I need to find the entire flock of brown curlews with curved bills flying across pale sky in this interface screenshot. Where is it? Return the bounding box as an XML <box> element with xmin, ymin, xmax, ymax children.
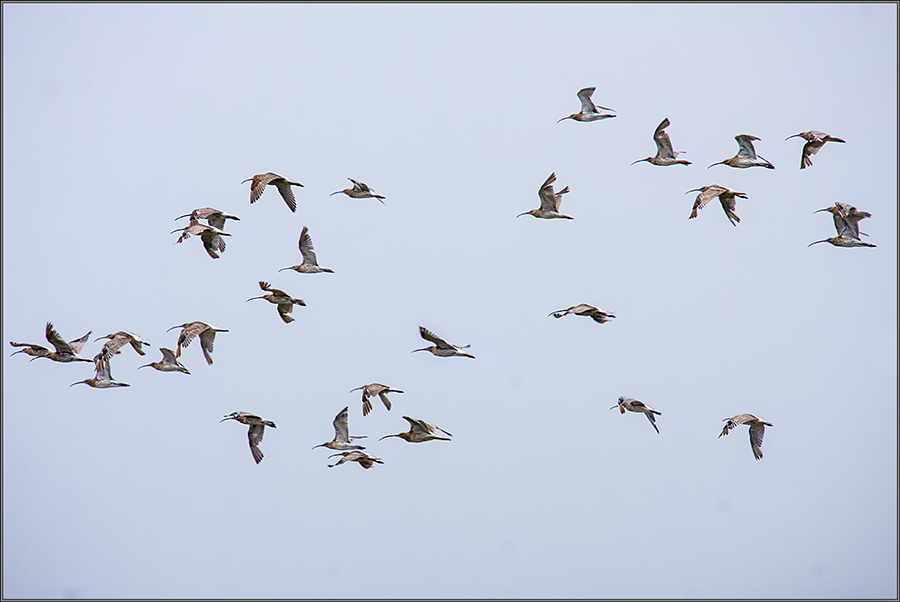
<box><xmin>10</xmin><ymin>87</ymin><xmax>875</xmax><ymax>468</ymax></box>
